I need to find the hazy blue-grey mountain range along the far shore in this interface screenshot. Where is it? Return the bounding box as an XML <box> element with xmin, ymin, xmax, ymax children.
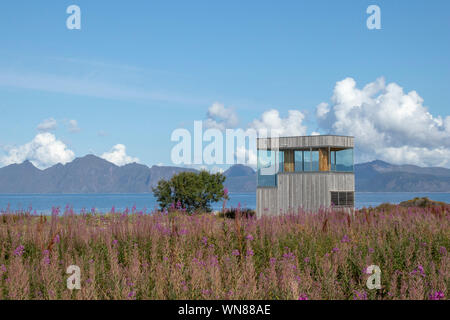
<box><xmin>0</xmin><ymin>155</ymin><xmax>450</xmax><ymax>193</ymax></box>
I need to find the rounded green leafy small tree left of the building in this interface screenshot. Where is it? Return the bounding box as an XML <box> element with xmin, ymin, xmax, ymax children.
<box><xmin>153</xmin><ymin>170</ymin><xmax>228</xmax><ymax>213</ymax></box>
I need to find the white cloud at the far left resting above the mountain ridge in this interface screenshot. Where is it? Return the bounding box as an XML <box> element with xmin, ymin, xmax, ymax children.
<box><xmin>0</xmin><ymin>132</ymin><xmax>75</xmax><ymax>169</ymax></box>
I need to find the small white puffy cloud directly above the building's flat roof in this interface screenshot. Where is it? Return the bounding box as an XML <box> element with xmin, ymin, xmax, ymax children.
<box><xmin>249</xmin><ymin>109</ymin><xmax>307</xmax><ymax>136</ymax></box>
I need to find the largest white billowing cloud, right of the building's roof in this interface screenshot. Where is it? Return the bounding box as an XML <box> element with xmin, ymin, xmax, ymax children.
<box><xmin>316</xmin><ymin>78</ymin><xmax>450</xmax><ymax>167</ymax></box>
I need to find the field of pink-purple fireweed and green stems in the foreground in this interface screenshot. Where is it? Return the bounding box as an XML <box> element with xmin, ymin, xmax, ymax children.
<box><xmin>0</xmin><ymin>207</ymin><xmax>450</xmax><ymax>300</ymax></box>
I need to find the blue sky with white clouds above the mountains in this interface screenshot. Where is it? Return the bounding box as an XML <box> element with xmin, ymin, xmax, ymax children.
<box><xmin>0</xmin><ymin>0</ymin><xmax>450</xmax><ymax>170</ymax></box>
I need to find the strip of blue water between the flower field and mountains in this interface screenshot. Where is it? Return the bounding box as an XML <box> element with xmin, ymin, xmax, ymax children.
<box><xmin>0</xmin><ymin>192</ymin><xmax>450</xmax><ymax>213</ymax></box>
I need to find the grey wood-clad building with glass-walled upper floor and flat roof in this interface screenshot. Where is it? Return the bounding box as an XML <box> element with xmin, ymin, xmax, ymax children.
<box><xmin>256</xmin><ymin>135</ymin><xmax>355</xmax><ymax>216</ymax></box>
